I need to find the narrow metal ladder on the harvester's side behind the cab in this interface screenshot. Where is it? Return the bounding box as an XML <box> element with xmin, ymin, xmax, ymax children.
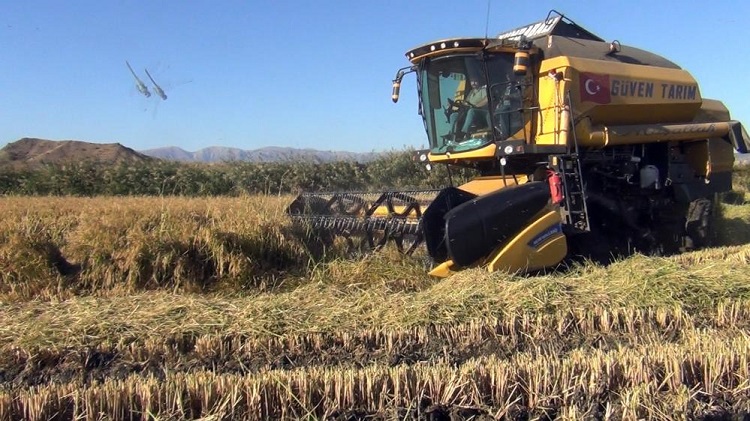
<box><xmin>557</xmin><ymin>92</ymin><xmax>591</xmax><ymax>231</ymax></box>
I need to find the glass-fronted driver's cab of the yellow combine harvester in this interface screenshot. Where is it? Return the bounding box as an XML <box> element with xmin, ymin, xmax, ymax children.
<box><xmin>394</xmin><ymin>39</ymin><xmax>532</xmax><ymax>155</ymax></box>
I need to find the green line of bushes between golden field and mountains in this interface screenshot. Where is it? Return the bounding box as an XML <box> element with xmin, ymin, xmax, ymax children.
<box><xmin>0</xmin><ymin>151</ymin><xmax>466</xmax><ymax>196</ymax></box>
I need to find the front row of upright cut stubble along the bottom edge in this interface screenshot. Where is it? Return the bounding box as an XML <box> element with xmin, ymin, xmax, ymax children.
<box><xmin>0</xmin><ymin>331</ymin><xmax>750</xmax><ymax>420</ymax></box>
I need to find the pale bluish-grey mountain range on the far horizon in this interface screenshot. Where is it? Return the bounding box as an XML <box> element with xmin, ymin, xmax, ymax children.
<box><xmin>141</xmin><ymin>146</ymin><xmax>379</xmax><ymax>163</ymax></box>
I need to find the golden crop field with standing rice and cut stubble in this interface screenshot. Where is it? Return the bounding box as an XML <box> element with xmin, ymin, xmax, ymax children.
<box><xmin>0</xmin><ymin>185</ymin><xmax>750</xmax><ymax>420</ymax></box>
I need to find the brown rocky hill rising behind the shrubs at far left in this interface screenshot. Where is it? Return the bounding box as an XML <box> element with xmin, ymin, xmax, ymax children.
<box><xmin>0</xmin><ymin>137</ymin><xmax>153</xmax><ymax>169</ymax></box>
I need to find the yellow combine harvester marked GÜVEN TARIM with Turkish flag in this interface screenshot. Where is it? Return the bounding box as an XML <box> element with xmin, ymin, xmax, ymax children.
<box><xmin>288</xmin><ymin>11</ymin><xmax>750</xmax><ymax>277</ymax></box>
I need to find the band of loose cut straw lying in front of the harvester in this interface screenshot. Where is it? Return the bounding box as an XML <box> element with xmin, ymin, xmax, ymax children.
<box><xmin>0</xmin><ymin>241</ymin><xmax>750</xmax><ymax>347</ymax></box>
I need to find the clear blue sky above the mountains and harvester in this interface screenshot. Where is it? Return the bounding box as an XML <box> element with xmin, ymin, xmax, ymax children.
<box><xmin>0</xmin><ymin>0</ymin><xmax>750</xmax><ymax>151</ymax></box>
